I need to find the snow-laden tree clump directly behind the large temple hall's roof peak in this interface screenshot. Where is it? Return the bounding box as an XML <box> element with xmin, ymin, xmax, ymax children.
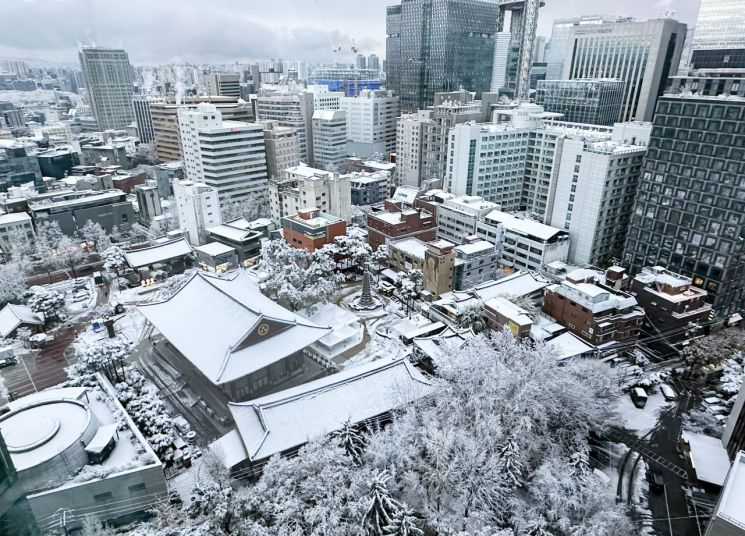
<box><xmin>261</xmin><ymin>239</ymin><xmax>338</xmax><ymax>311</ymax></box>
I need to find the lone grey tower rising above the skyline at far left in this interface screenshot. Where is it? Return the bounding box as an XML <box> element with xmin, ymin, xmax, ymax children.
<box><xmin>79</xmin><ymin>47</ymin><xmax>134</xmax><ymax>130</ymax></box>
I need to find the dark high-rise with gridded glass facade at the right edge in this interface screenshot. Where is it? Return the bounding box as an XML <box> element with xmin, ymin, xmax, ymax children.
<box><xmin>624</xmin><ymin>83</ymin><xmax>745</xmax><ymax>317</ymax></box>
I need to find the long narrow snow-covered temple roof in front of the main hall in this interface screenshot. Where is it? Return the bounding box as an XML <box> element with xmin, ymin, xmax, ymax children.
<box><xmin>228</xmin><ymin>357</ymin><xmax>434</xmax><ymax>461</ymax></box>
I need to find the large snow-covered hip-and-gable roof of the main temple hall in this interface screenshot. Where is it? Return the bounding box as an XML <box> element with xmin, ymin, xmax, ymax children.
<box><xmin>139</xmin><ymin>273</ymin><xmax>331</xmax><ymax>385</ymax></box>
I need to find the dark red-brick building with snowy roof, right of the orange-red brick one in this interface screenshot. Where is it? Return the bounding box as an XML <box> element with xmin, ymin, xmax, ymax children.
<box><xmin>367</xmin><ymin>200</ymin><xmax>437</xmax><ymax>249</ymax></box>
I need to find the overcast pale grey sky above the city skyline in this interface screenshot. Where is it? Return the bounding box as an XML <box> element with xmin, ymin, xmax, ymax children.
<box><xmin>0</xmin><ymin>0</ymin><xmax>700</xmax><ymax>65</ymax></box>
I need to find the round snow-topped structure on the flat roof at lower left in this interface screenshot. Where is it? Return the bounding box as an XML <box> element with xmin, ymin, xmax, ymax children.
<box><xmin>0</xmin><ymin>398</ymin><xmax>98</xmax><ymax>489</ymax></box>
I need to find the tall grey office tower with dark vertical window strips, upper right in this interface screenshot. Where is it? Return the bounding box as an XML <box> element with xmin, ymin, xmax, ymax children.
<box><xmin>552</xmin><ymin>19</ymin><xmax>686</xmax><ymax>121</ymax></box>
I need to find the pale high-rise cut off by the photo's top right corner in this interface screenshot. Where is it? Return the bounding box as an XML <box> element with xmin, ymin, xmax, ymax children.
<box><xmin>690</xmin><ymin>0</ymin><xmax>745</xmax><ymax>69</ymax></box>
